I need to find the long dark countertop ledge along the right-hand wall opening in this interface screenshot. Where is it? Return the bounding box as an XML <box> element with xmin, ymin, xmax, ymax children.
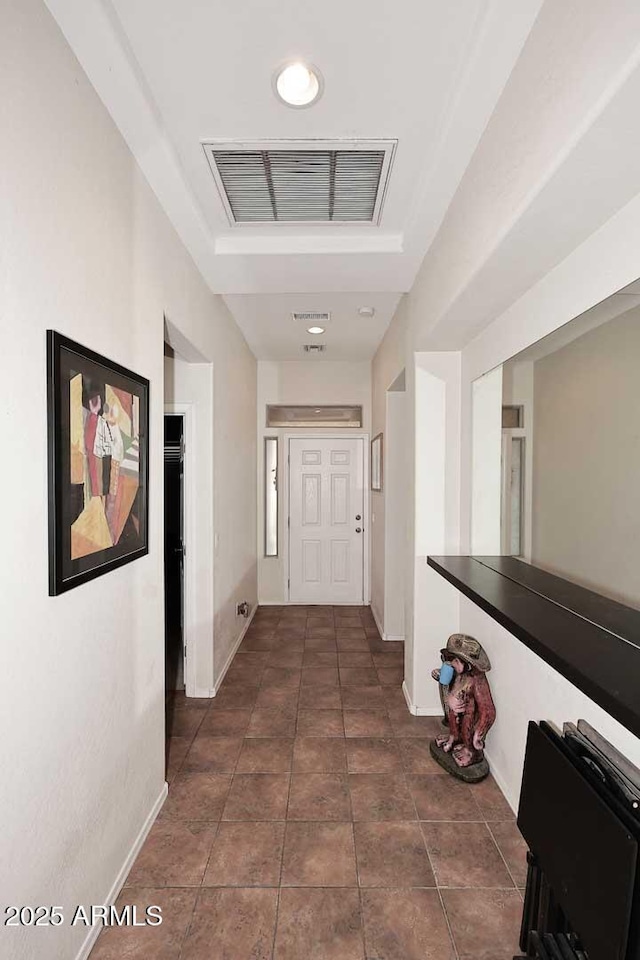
<box><xmin>427</xmin><ymin>556</ymin><xmax>640</xmax><ymax>737</ymax></box>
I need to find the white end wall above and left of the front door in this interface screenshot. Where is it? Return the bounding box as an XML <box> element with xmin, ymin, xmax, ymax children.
<box><xmin>257</xmin><ymin>360</ymin><xmax>371</xmax><ymax>603</ymax></box>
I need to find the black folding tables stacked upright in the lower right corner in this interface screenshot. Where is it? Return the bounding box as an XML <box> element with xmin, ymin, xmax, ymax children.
<box><xmin>514</xmin><ymin>722</ymin><xmax>640</xmax><ymax>960</ymax></box>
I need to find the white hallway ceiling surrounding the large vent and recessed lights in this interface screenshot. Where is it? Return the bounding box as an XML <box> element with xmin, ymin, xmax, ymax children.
<box><xmin>47</xmin><ymin>0</ymin><xmax>542</xmax><ymax>359</ymax></box>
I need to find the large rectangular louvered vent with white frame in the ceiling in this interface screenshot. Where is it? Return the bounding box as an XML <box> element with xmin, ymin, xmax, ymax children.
<box><xmin>202</xmin><ymin>140</ymin><xmax>396</xmax><ymax>224</ymax></box>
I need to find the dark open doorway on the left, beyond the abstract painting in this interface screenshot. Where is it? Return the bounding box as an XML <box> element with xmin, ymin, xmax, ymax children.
<box><xmin>164</xmin><ymin>414</ymin><xmax>185</xmax><ymax>704</ymax></box>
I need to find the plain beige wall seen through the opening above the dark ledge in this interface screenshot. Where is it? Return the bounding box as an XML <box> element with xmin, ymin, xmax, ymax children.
<box><xmin>533</xmin><ymin>308</ymin><xmax>640</xmax><ymax>607</ymax></box>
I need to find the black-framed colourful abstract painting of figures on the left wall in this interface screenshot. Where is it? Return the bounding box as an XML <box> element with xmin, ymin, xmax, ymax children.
<box><xmin>47</xmin><ymin>330</ymin><xmax>149</xmax><ymax>596</ymax></box>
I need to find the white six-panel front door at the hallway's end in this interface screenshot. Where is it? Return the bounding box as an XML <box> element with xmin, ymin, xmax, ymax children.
<box><xmin>289</xmin><ymin>437</ymin><xmax>364</xmax><ymax>603</ymax></box>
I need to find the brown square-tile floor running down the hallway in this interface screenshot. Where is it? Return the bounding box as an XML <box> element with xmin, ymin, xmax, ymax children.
<box><xmin>91</xmin><ymin>607</ymin><xmax>525</xmax><ymax>960</ymax></box>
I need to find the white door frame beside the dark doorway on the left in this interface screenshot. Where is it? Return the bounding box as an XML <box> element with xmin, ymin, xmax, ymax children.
<box><xmin>163</xmin><ymin>401</ymin><xmax>198</xmax><ymax>697</ymax></box>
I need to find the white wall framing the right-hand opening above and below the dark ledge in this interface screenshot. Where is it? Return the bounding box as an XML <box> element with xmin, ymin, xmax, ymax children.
<box><xmin>459</xmin><ymin>198</ymin><xmax>640</xmax><ymax>805</ymax></box>
